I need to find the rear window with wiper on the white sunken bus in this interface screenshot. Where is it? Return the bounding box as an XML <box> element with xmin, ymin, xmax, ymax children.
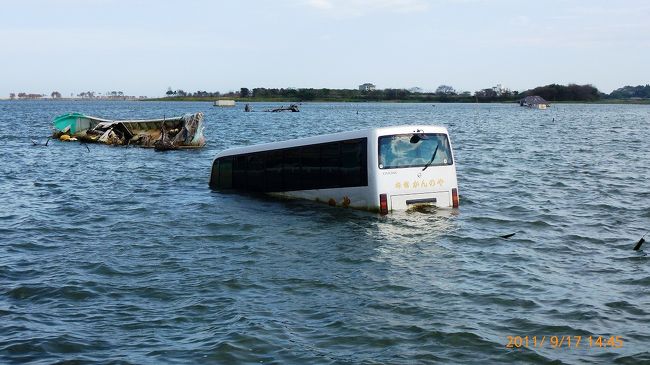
<box><xmin>379</xmin><ymin>133</ymin><xmax>453</xmax><ymax>169</ymax></box>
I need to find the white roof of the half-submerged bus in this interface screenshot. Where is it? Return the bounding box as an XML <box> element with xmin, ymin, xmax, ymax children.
<box><xmin>215</xmin><ymin>125</ymin><xmax>448</xmax><ymax>159</ymax></box>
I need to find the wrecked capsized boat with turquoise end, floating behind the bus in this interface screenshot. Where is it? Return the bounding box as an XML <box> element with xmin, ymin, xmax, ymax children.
<box><xmin>53</xmin><ymin>112</ymin><xmax>205</xmax><ymax>150</ymax></box>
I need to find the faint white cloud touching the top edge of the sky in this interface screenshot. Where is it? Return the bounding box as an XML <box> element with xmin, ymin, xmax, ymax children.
<box><xmin>305</xmin><ymin>0</ymin><xmax>429</xmax><ymax>17</ymax></box>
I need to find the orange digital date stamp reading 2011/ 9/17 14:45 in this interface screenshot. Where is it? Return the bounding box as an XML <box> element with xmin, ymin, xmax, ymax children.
<box><xmin>506</xmin><ymin>336</ymin><xmax>623</xmax><ymax>349</ymax></box>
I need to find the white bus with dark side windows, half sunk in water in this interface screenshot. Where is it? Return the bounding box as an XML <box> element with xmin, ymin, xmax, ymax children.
<box><xmin>210</xmin><ymin>125</ymin><xmax>459</xmax><ymax>214</ymax></box>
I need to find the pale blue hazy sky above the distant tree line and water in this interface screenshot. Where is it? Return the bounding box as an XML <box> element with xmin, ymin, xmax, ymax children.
<box><xmin>0</xmin><ymin>0</ymin><xmax>650</xmax><ymax>98</ymax></box>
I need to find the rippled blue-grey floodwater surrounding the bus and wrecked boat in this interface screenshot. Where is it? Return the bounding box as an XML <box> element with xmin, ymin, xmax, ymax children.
<box><xmin>0</xmin><ymin>101</ymin><xmax>650</xmax><ymax>364</ymax></box>
